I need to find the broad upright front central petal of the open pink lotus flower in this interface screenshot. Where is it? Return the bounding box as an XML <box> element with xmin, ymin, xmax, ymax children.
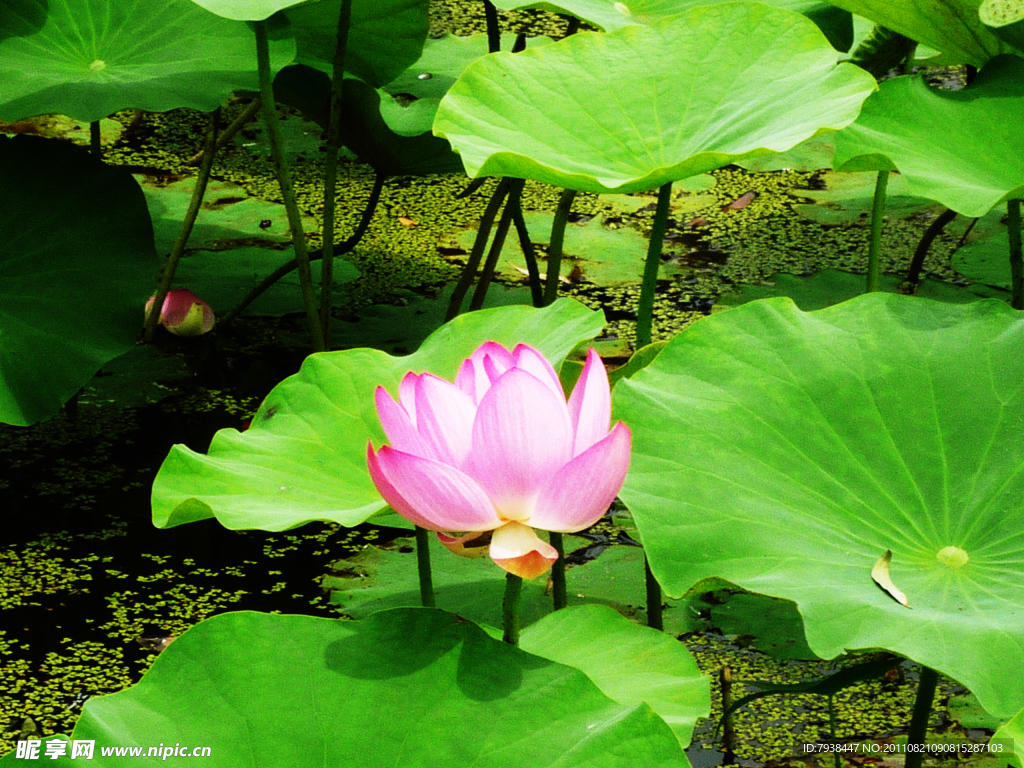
<box><xmin>462</xmin><ymin>369</ymin><xmax>572</xmax><ymax>530</ymax></box>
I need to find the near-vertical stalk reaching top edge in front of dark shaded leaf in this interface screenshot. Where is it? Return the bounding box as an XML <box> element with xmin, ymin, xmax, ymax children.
<box><xmin>321</xmin><ymin>0</ymin><xmax>352</xmax><ymax>349</ymax></box>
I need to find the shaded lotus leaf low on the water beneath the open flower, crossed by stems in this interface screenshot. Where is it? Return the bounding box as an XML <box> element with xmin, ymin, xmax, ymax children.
<box><xmin>323</xmin><ymin>536</ymin><xmax>703</xmax><ymax>635</ymax></box>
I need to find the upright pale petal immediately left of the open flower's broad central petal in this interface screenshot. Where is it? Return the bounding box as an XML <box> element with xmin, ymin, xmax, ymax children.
<box><xmin>415</xmin><ymin>374</ymin><xmax>476</xmax><ymax>467</ymax></box>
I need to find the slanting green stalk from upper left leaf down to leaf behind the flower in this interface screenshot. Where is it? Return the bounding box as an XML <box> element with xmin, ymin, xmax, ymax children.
<box><xmin>254</xmin><ymin>19</ymin><xmax>326</xmax><ymax>352</ymax></box>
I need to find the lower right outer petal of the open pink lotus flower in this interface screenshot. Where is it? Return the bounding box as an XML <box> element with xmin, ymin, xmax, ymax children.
<box><xmin>529</xmin><ymin>422</ymin><xmax>633</xmax><ymax>534</ymax></box>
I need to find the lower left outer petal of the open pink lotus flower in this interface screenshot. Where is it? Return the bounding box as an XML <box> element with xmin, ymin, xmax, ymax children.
<box><xmin>367</xmin><ymin>444</ymin><xmax>504</xmax><ymax>530</ymax></box>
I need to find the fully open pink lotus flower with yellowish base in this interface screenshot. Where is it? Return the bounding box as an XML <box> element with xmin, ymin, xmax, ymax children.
<box><xmin>367</xmin><ymin>341</ymin><xmax>632</xmax><ymax>579</ymax></box>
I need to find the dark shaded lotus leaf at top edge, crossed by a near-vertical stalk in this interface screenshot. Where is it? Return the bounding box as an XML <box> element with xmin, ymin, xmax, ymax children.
<box><xmin>287</xmin><ymin>0</ymin><xmax>430</xmax><ymax>86</ymax></box>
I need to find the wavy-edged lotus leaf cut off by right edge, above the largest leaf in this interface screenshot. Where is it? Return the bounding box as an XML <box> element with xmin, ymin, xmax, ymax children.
<box><xmin>835</xmin><ymin>56</ymin><xmax>1024</xmax><ymax>216</ymax></box>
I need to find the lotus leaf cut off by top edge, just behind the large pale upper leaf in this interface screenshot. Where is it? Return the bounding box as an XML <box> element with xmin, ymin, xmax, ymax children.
<box><xmin>495</xmin><ymin>0</ymin><xmax>853</xmax><ymax>50</ymax></box>
